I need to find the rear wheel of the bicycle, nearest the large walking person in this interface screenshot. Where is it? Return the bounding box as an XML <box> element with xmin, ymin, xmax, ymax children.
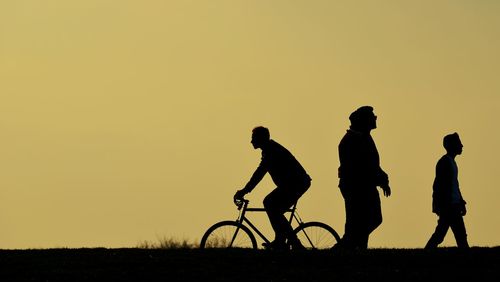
<box><xmin>294</xmin><ymin>221</ymin><xmax>340</xmax><ymax>250</ymax></box>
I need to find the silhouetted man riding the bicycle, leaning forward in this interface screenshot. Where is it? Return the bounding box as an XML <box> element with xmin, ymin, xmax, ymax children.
<box><xmin>234</xmin><ymin>126</ymin><xmax>311</xmax><ymax>250</ymax></box>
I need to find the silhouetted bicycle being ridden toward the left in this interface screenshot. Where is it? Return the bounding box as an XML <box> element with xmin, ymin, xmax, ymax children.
<box><xmin>200</xmin><ymin>199</ymin><xmax>340</xmax><ymax>250</ymax></box>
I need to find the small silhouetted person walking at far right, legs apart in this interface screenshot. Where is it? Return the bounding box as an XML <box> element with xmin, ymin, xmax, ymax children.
<box><xmin>425</xmin><ymin>132</ymin><xmax>469</xmax><ymax>249</ymax></box>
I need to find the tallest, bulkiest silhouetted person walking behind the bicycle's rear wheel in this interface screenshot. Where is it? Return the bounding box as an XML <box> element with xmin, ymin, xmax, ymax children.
<box><xmin>334</xmin><ymin>106</ymin><xmax>391</xmax><ymax>250</ymax></box>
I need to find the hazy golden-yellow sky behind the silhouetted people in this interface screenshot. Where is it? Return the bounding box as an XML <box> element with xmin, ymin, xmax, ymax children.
<box><xmin>0</xmin><ymin>0</ymin><xmax>500</xmax><ymax>249</ymax></box>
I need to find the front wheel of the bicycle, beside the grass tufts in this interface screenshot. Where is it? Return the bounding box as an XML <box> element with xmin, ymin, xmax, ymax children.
<box><xmin>200</xmin><ymin>221</ymin><xmax>257</xmax><ymax>249</ymax></box>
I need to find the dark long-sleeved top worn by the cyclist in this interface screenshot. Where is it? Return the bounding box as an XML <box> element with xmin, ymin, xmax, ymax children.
<box><xmin>244</xmin><ymin>140</ymin><xmax>311</xmax><ymax>192</ymax></box>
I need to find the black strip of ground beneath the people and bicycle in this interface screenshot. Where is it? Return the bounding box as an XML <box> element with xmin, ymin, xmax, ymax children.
<box><xmin>0</xmin><ymin>247</ymin><xmax>500</xmax><ymax>282</ymax></box>
